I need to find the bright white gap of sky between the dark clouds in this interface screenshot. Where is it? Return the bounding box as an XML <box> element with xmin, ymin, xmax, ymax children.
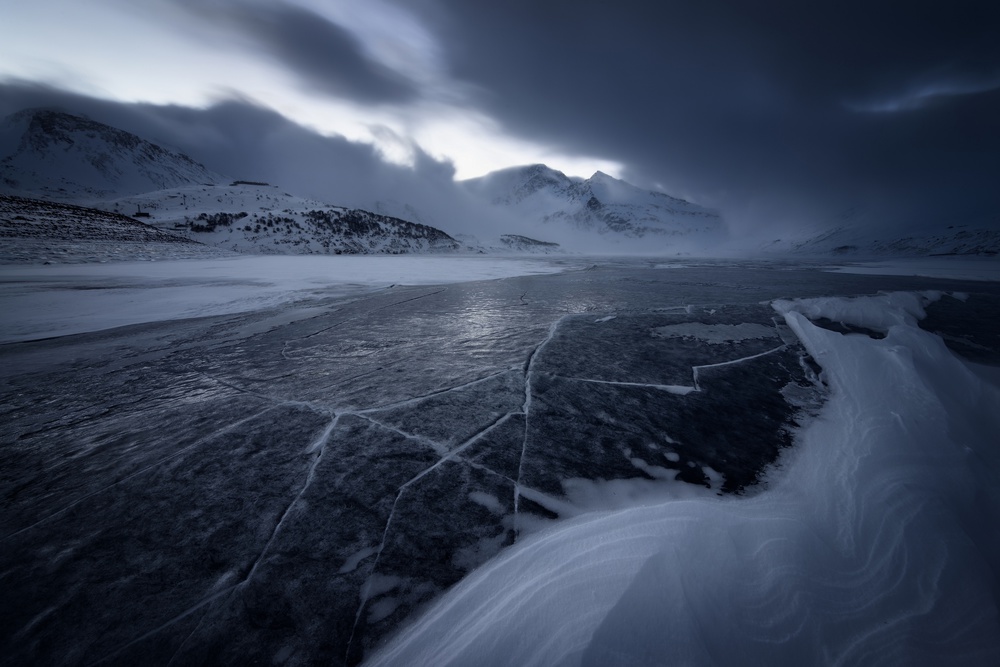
<box><xmin>0</xmin><ymin>0</ymin><xmax>622</xmax><ymax>179</ymax></box>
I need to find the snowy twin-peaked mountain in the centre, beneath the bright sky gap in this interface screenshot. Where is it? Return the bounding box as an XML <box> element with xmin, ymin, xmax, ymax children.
<box><xmin>462</xmin><ymin>164</ymin><xmax>725</xmax><ymax>249</ymax></box>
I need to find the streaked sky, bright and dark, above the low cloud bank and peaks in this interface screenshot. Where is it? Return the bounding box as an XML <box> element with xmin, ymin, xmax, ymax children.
<box><xmin>0</xmin><ymin>0</ymin><xmax>1000</xmax><ymax>237</ymax></box>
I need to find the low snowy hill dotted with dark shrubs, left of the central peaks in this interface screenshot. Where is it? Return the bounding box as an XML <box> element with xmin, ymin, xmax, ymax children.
<box><xmin>92</xmin><ymin>181</ymin><xmax>459</xmax><ymax>255</ymax></box>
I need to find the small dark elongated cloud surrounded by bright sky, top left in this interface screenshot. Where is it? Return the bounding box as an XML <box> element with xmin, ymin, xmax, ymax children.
<box><xmin>176</xmin><ymin>0</ymin><xmax>418</xmax><ymax>104</ymax></box>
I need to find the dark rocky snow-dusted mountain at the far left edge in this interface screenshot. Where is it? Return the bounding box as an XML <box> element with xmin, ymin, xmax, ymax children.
<box><xmin>0</xmin><ymin>109</ymin><xmax>227</xmax><ymax>201</ymax></box>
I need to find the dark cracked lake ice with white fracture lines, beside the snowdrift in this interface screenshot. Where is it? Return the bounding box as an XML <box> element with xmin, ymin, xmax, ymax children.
<box><xmin>0</xmin><ymin>269</ymin><xmax>1000</xmax><ymax>665</ymax></box>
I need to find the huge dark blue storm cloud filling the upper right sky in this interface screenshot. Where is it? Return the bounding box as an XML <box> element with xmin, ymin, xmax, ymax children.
<box><xmin>401</xmin><ymin>0</ymin><xmax>1000</xmax><ymax>235</ymax></box>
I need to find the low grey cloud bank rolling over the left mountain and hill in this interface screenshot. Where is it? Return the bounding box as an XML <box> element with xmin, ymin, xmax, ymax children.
<box><xmin>0</xmin><ymin>82</ymin><xmax>526</xmax><ymax>236</ymax></box>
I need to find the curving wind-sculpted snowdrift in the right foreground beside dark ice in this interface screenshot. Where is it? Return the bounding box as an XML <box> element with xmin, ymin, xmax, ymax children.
<box><xmin>369</xmin><ymin>294</ymin><xmax>1000</xmax><ymax>665</ymax></box>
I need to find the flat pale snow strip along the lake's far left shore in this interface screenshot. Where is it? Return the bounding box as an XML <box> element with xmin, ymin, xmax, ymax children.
<box><xmin>0</xmin><ymin>255</ymin><xmax>568</xmax><ymax>343</ymax></box>
